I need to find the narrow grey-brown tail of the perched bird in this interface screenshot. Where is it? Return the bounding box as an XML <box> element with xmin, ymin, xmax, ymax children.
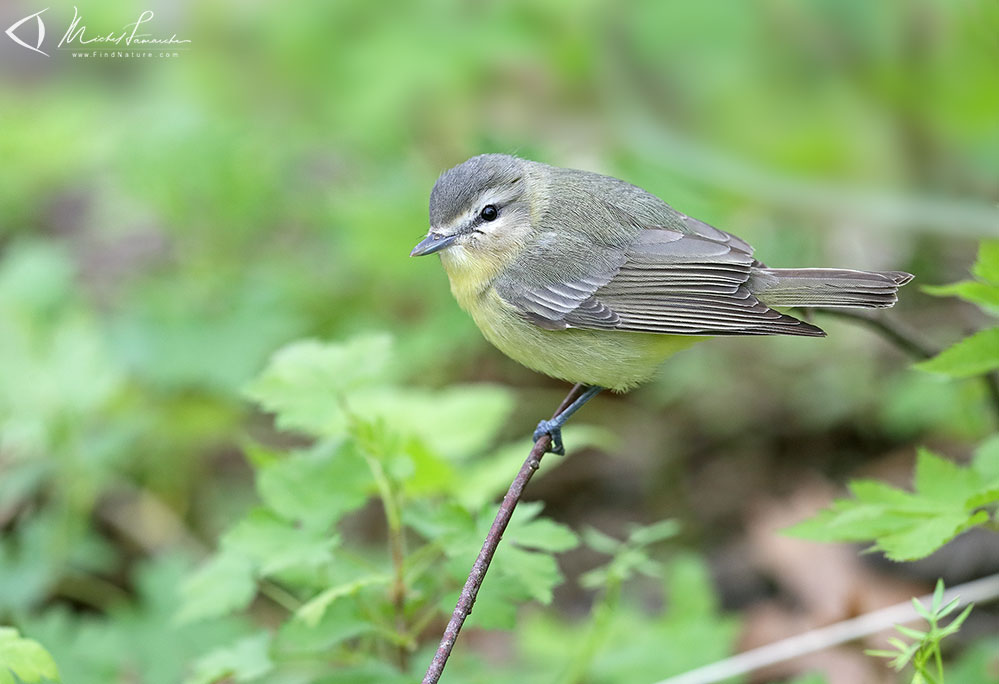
<box><xmin>749</xmin><ymin>267</ymin><xmax>912</xmax><ymax>309</ymax></box>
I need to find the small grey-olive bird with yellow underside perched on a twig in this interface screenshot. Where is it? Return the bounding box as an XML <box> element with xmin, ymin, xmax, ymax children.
<box><xmin>410</xmin><ymin>154</ymin><xmax>912</xmax><ymax>453</ymax></box>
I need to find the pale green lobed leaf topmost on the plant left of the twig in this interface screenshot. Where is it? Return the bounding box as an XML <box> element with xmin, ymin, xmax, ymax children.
<box><xmin>246</xmin><ymin>335</ymin><xmax>391</xmax><ymax>437</ymax></box>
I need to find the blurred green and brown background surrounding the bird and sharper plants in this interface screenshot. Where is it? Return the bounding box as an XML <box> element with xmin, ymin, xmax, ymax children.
<box><xmin>0</xmin><ymin>0</ymin><xmax>999</xmax><ymax>682</ymax></box>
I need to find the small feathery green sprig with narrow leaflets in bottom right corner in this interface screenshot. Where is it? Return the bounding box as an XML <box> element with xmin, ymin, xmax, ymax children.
<box><xmin>867</xmin><ymin>580</ymin><xmax>974</xmax><ymax>684</ymax></box>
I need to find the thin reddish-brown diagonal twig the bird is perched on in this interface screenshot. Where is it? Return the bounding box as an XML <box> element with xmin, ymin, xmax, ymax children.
<box><xmin>423</xmin><ymin>385</ymin><xmax>584</xmax><ymax>684</ymax></box>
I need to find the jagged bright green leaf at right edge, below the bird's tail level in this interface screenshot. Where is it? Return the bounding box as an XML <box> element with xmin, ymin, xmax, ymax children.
<box><xmin>788</xmin><ymin>444</ymin><xmax>999</xmax><ymax>561</ymax></box>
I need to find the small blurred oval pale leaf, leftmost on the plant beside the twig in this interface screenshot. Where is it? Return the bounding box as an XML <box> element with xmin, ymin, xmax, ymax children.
<box><xmin>176</xmin><ymin>552</ymin><xmax>257</xmax><ymax>624</ymax></box>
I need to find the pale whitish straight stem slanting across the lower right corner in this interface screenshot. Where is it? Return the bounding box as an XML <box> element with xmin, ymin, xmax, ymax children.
<box><xmin>657</xmin><ymin>574</ymin><xmax>999</xmax><ymax>684</ymax></box>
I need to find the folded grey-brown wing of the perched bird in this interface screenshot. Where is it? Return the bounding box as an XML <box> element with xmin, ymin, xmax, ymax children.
<box><xmin>497</xmin><ymin>208</ymin><xmax>824</xmax><ymax>336</ymax></box>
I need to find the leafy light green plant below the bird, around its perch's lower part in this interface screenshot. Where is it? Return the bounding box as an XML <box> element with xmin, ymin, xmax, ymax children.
<box><xmin>177</xmin><ymin>335</ymin><xmax>585</xmax><ymax>682</ymax></box>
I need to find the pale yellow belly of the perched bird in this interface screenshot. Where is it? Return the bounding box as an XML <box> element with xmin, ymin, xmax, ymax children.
<box><xmin>455</xmin><ymin>288</ymin><xmax>707</xmax><ymax>392</ymax></box>
